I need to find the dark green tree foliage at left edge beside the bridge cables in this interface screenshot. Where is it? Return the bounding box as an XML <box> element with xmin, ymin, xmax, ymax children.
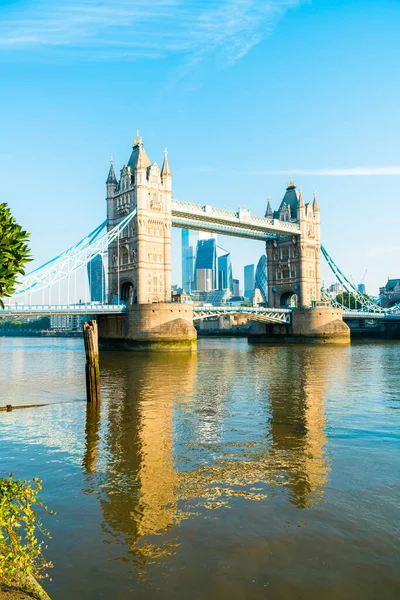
<box><xmin>0</xmin><ymin>202</ymin><xmax>31</xmax><ymax>308</ymax></box>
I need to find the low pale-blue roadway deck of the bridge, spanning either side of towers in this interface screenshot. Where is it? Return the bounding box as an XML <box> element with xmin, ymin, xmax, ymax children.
<box><xmin>0</xmin><ymin>302</ymin><xmax>400</xmax><ymax>324</ymax></box>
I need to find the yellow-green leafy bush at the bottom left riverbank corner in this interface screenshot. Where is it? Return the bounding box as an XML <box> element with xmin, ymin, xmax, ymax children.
<box><xmin>0</xmin><ymin>474</ymin><xmax>54</xmax><ymax>589</ymax></box>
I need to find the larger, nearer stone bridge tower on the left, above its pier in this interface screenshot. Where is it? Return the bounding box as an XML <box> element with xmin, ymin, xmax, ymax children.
<box><xmin>106</xmin><ymin>134</ymin><xmax>172</xmax><ymax>304</ymax></box>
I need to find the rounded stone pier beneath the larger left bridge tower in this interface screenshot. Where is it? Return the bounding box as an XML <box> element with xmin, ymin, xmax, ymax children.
<box><xmin>99</xmin><ymin>304</ymin><xmax>197</xmax><ymax>352</ymax></box>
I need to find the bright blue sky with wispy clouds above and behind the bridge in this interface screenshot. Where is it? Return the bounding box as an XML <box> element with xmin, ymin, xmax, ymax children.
<box><xmin>0</xmin><ymin>0</ymin><xmax>400</xmax><ymax>293</ymax></box>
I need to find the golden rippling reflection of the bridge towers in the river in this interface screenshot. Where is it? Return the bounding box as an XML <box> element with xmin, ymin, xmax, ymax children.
<box><xmin>83</xmin><ymin>341</ymin><xmax>345</xmax><ymax>561</ymax></box>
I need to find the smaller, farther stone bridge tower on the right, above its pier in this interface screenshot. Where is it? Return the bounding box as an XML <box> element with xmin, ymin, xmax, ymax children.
<box><xmin>265</xmin><ymin>180</ymin><xmax>321</xmax><ymax>308</ymax></box>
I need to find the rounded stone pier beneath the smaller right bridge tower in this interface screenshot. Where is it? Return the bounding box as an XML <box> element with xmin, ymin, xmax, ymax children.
<box><xmin>248</xmin><ymin>307</ymin><xmax>350</xmax><ymax>344</ymax></box>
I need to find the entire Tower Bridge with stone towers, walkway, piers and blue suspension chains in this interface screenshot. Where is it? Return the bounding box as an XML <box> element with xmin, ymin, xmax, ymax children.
<box><xmin>0</xmin><ymin>135</ymin><xmax>396</xmax><ymax>349</ymax></box>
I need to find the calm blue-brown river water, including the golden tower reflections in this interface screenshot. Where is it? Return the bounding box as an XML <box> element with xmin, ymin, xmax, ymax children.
<box><xmin>0</xmin><ymin>338</ymin><xmax>400</xmax><ymax>600</ymax></box>
